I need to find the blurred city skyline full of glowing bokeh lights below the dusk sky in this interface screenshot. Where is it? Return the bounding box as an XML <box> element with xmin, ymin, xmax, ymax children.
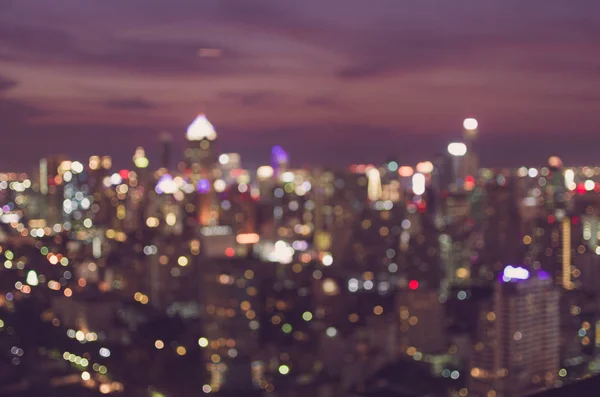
<box><xmin>0</xmin><ymin>114</ymin><xmax>600</xmax><ymax>397</ymax></box>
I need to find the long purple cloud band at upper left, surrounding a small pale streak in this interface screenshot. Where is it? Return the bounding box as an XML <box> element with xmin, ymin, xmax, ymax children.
<box><xmin>0</xmin><ymin>24</ymin><xmax>274</xmax><ymax>76</ymax></box>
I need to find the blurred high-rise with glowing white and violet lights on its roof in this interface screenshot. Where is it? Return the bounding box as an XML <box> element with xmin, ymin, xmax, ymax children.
<box><xmin>468</xmin><ymin>266</ymin><xmax>560</xmax><ymax>397</ymax></box>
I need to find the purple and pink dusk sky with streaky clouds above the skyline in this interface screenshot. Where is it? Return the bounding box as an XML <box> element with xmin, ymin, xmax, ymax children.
<box><xmin>0</xmin><ymin>0</ymin><xmax>600</xmax><ymax>170</ymax></box>
